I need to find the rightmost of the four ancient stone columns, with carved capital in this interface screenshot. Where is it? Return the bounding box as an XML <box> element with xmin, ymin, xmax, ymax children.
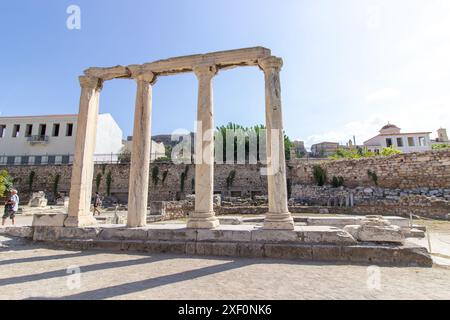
<box><xmin>259</xmin><ymin>57</ymin><xmax>294</xmax><ymax>230</ymax></box>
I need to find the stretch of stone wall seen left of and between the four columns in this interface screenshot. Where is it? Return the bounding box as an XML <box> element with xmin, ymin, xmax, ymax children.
<box><xmin>4</xmin><ymin>162</ymin><xmax>267</xmax><ymax>202</ymax></box>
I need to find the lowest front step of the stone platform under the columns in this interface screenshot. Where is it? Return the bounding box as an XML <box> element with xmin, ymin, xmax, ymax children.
<box><xmin>44</xmin><ymin>239</ymin><xmax>433</xmax><ymax>267</ymax></box>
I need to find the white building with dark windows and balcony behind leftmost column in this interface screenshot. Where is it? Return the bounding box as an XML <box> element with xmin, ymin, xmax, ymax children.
<box><xmin>0</xmin><ymin>113</ymin><xmax>123</xmax><ymax>165</ymax></box>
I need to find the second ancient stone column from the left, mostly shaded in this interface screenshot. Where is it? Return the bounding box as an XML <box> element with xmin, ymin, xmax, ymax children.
<box><xmin>127</xmin><ymin>73</ymin><xmax>155</xmax><ymax>228</ymax></box>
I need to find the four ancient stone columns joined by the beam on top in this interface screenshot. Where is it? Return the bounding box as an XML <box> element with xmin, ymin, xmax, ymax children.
<box><xmin>65</xmin><ymin>47</ymin><xmax>294</xmax><ymax>230</ymax></box>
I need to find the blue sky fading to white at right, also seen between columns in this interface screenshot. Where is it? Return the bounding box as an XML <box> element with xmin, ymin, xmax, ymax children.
<box><xmin>0</xmin><ymin>0</ymin><xmax>450</xmax><ymax>145</ymax></box>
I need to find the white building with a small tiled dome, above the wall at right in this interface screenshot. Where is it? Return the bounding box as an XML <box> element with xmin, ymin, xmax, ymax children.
<box><xmin>364</xmin><ymin>123</ymin><xmax>431</xmax><ymax>153</ymax></box>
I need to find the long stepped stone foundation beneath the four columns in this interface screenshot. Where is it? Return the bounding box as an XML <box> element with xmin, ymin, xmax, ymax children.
<box><xmin>0</xmin><ymin>225</ymin><xmax>432</xmax><ymax>267</ymax></box>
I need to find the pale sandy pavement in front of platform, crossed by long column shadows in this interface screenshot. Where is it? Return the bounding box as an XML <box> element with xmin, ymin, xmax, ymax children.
<box><xmin>0</xmin><ymin>237</ymin><xmax>450</xmax><ymax>299</ymax></box>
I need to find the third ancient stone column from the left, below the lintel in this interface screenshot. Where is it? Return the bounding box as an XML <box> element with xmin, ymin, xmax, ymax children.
<box><xmin>187</xmin><ymin>65</ymin><xmax>219</xmax><ymax>229</ymax></box>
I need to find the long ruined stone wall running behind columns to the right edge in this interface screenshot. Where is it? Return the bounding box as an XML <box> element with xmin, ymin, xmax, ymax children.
<box><xmin>0</xmin><ymin>150</ymin><xmax>450</xmax><ymax>218</ymax></box>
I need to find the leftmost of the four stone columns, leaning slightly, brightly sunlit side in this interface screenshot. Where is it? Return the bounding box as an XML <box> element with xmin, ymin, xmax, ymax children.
<box><xmin>64</xmin><ymin>76</ymin><xmax>102</xmax><ymax>227</ymax></box>
